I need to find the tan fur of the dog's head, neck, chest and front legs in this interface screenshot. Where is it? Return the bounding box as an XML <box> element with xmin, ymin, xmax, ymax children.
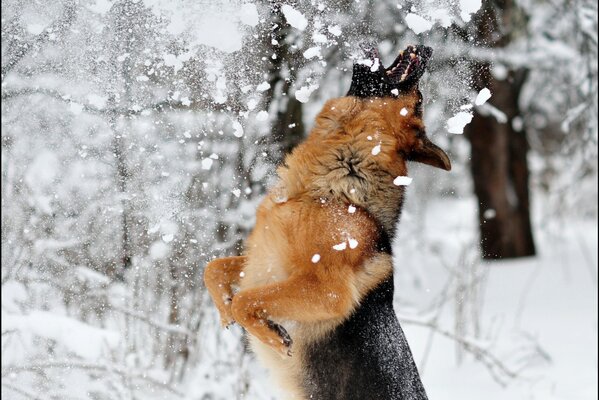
<box><xmin>205</xmin><ymin>91</ymin><xmax>442</xmax><ymax>399</ymax></box>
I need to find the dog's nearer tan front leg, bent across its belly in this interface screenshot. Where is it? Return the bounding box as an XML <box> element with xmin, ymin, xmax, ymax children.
<box><xmin>232</xmin><ymin>274</ymin><xmax>355</xmax><ymax>356</ymax></box>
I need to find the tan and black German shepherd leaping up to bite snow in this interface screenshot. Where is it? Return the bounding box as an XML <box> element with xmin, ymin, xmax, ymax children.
<box><xmin>204</xmin><ymin>46</ymin><xmax>451</xmax><ymax>400</ymax></box>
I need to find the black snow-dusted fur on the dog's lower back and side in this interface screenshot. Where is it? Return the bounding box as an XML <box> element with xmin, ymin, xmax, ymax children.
<box><xmin>304</xmin><ymin>277</ymin><xmax>427</xmax><ymax>400</ymax></box>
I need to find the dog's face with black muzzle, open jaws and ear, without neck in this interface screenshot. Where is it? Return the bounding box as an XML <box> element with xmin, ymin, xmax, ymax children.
<box><xmin>347</xmin><ymin>46</ymin><xmax>451</xmax><ymax>171</ymax></box>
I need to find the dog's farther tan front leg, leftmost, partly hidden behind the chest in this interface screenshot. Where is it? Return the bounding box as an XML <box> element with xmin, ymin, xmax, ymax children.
<box><xmin>204</xmin><ymin>256</ymin><xmax>247</xmax><ymax>327</ymax></box>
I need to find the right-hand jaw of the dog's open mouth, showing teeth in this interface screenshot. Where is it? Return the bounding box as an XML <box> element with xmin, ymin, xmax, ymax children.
<box><xmin>385</xmin><ymin>46</ymin><xmax>433</xmax><ymax>86</ymax></box>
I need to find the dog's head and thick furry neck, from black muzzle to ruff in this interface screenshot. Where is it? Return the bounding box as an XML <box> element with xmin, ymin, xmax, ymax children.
<box><xmin>279</xmin><ymin>46</ymin><xmax>451</xmax><ymax>231</ymax></box>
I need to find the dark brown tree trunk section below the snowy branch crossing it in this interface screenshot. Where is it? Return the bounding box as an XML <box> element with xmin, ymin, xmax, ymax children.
<box><xmin>465</xmin><ymin>64</ymin><xmax>535</xmax><ymax>259</ymax></box>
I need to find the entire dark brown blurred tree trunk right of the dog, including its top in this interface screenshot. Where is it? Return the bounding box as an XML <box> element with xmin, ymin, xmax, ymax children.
<box><xmin>465</xmin><ymin>0</ymin><xmax>535</xmax><ymax>259</ymax></box>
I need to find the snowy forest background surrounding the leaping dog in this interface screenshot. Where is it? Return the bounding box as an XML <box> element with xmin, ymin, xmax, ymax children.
<box><xmin>2</xmin><ymin>0</ymin><xmax>598</xmax><ymax>400</ymax></box>
